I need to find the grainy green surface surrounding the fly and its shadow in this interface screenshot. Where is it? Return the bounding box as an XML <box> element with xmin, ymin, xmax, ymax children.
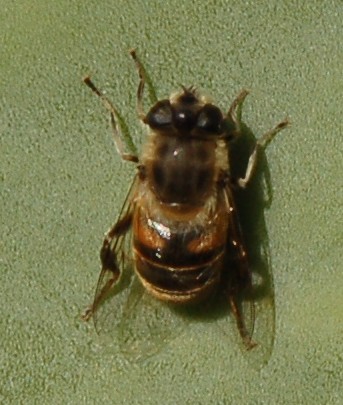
<box><xmin>0</xmin><ymin>0</ymin><xmax>343</xmax><ymax>404</ymax></box>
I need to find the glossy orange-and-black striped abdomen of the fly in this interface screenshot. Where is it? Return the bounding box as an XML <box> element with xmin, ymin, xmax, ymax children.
<box><xmin>133</xmin><ymin>202</ymin><xmax>227</xmax><ymax>303</ymax></box>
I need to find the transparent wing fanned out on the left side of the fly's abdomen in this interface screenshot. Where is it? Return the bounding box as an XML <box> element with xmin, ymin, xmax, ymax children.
<box><xmin>84</xmin><ymin>174</ymin><xmax>188</xmax><ymax>361</ymax></box>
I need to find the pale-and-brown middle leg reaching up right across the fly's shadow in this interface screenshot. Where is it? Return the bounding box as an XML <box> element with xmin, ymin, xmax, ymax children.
<box><xmin>237</xmin><ymin>118</ymin><xmax>290</xmax><ymax>188</ymax></box>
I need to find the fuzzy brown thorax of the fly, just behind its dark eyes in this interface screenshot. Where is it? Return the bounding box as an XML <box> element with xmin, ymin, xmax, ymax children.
<box><xmin>142</xmin><ymin>134</ymin><xmax>217</xmax><ymax>206</ymax></box>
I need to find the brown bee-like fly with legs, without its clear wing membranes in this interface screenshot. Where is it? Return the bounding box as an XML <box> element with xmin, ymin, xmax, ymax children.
<box><xmin>83</xmin><ymin>50</ymin><xmax>289</xmax><ymax>349</ymax></box>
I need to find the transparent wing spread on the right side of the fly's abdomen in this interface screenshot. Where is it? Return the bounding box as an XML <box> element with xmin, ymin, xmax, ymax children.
<box><xmin>225</xmin><ymin>187</ymin><xmax>275</xmax><ymax>367</ymax></box>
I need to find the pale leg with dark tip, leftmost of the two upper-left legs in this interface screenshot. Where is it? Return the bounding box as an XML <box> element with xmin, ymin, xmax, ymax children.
<box><xmin>83</xmin><ymin>76</ymin><xmax>139</xmax><ymax>163</ymax></box>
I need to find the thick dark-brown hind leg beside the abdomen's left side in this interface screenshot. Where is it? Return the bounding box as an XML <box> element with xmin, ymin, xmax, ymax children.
<box><xmin>82</xmin><ymin>212</ymin><xmax>132</xmax><ymax>321</ymax></box>
